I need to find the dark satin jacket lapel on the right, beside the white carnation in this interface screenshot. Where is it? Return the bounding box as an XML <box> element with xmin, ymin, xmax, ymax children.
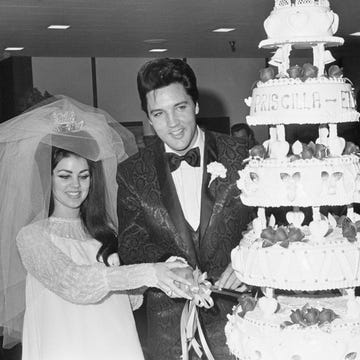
<box><xmin>200</xmin><ymin>131</ymin><xmax>218</xmax><ymax>241</ymax></box>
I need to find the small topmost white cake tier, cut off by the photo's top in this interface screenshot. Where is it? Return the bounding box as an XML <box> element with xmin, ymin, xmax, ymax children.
<box><xmin>259</xmin><ymin>0</ymin><xmax>339</xmax><ymax>46</ymax></box>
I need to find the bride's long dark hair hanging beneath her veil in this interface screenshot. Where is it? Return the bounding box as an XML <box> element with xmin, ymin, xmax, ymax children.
<box><xmin>49</xmin><ymin>146</ymin><xmax>117</xmax><ymax>266</ymax></box>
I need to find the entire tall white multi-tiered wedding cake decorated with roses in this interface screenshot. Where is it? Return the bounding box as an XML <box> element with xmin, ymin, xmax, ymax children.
<box><xmin>225</xmin><ymin>0</ymin><xmax>360</xmax><ymax>360</ymax></box>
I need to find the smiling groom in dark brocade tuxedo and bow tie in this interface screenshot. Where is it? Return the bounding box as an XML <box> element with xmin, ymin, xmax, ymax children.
<box><xmin>117</xmin><ymin>59</ymin><xmax>249</xmax><ymax>360</ymax></box>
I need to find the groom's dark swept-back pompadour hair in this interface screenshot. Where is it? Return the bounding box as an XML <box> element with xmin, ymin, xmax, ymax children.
<box><xmin>137</xmin><ymin>58</ymin><xmax>199</xmax><ymax>114</ymax></box>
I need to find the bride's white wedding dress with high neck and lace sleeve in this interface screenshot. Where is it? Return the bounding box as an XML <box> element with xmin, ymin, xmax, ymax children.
<box><xmin>17</xmin><ymin>218</ymin><xmax>155</xmax><ymax>360</ymax></box>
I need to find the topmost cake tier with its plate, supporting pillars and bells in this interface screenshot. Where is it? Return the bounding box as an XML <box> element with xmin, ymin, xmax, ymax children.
<box><xmin>259</xmin><ymin>0</ymin><xmax>344</xmax><ymax>75</ymax></box>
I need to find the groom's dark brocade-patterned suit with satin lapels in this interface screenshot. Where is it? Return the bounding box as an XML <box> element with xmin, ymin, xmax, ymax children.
<box><xmin>117</xmin><ymin>131</ymin><xmax>250</xmax><ymax>360</ymax></box>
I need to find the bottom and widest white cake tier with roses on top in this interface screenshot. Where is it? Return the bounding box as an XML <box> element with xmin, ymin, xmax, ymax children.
<box><xmin>225</xmin><ymin>297</ymin><xmax>360</xmax><ymax>360</ymax></box>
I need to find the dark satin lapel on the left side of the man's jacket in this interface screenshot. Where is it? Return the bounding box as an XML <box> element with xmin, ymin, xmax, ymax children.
<box><xmin>154</xmin><ymin>141</ymin><xmax>198</xmax><ymax>265</ymax></box>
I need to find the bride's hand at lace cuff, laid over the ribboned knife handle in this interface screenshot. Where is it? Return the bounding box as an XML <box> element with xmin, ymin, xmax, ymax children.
<box><xmin>154</xmin><ymin>262</ymin><xmax>192</xmax><ymax>300</ymax></box>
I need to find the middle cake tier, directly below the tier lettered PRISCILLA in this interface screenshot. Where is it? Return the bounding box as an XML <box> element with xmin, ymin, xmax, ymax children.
<box><xmin>238</xmin><ymin>154</ymin><xmax>360</xmax><ymax>207</ymax></box>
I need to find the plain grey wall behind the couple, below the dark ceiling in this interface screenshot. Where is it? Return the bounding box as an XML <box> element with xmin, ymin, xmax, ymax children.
<box><xmin>32</xmin><ymin>57</ymin><xmax>267</xmax><ymax>139</ymax></box>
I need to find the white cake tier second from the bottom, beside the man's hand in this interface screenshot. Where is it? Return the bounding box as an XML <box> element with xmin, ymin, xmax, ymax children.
<box><xmin>231</xmin><ymin>226</ymin><xmax>360</xmax><ymax>291</ymax></box>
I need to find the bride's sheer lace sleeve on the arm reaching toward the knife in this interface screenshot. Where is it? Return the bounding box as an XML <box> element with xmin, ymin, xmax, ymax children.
<box><xmin>17</xmin><ymin>225</ymin><xmax>157</xmax><ymax>304</ymax></box>
